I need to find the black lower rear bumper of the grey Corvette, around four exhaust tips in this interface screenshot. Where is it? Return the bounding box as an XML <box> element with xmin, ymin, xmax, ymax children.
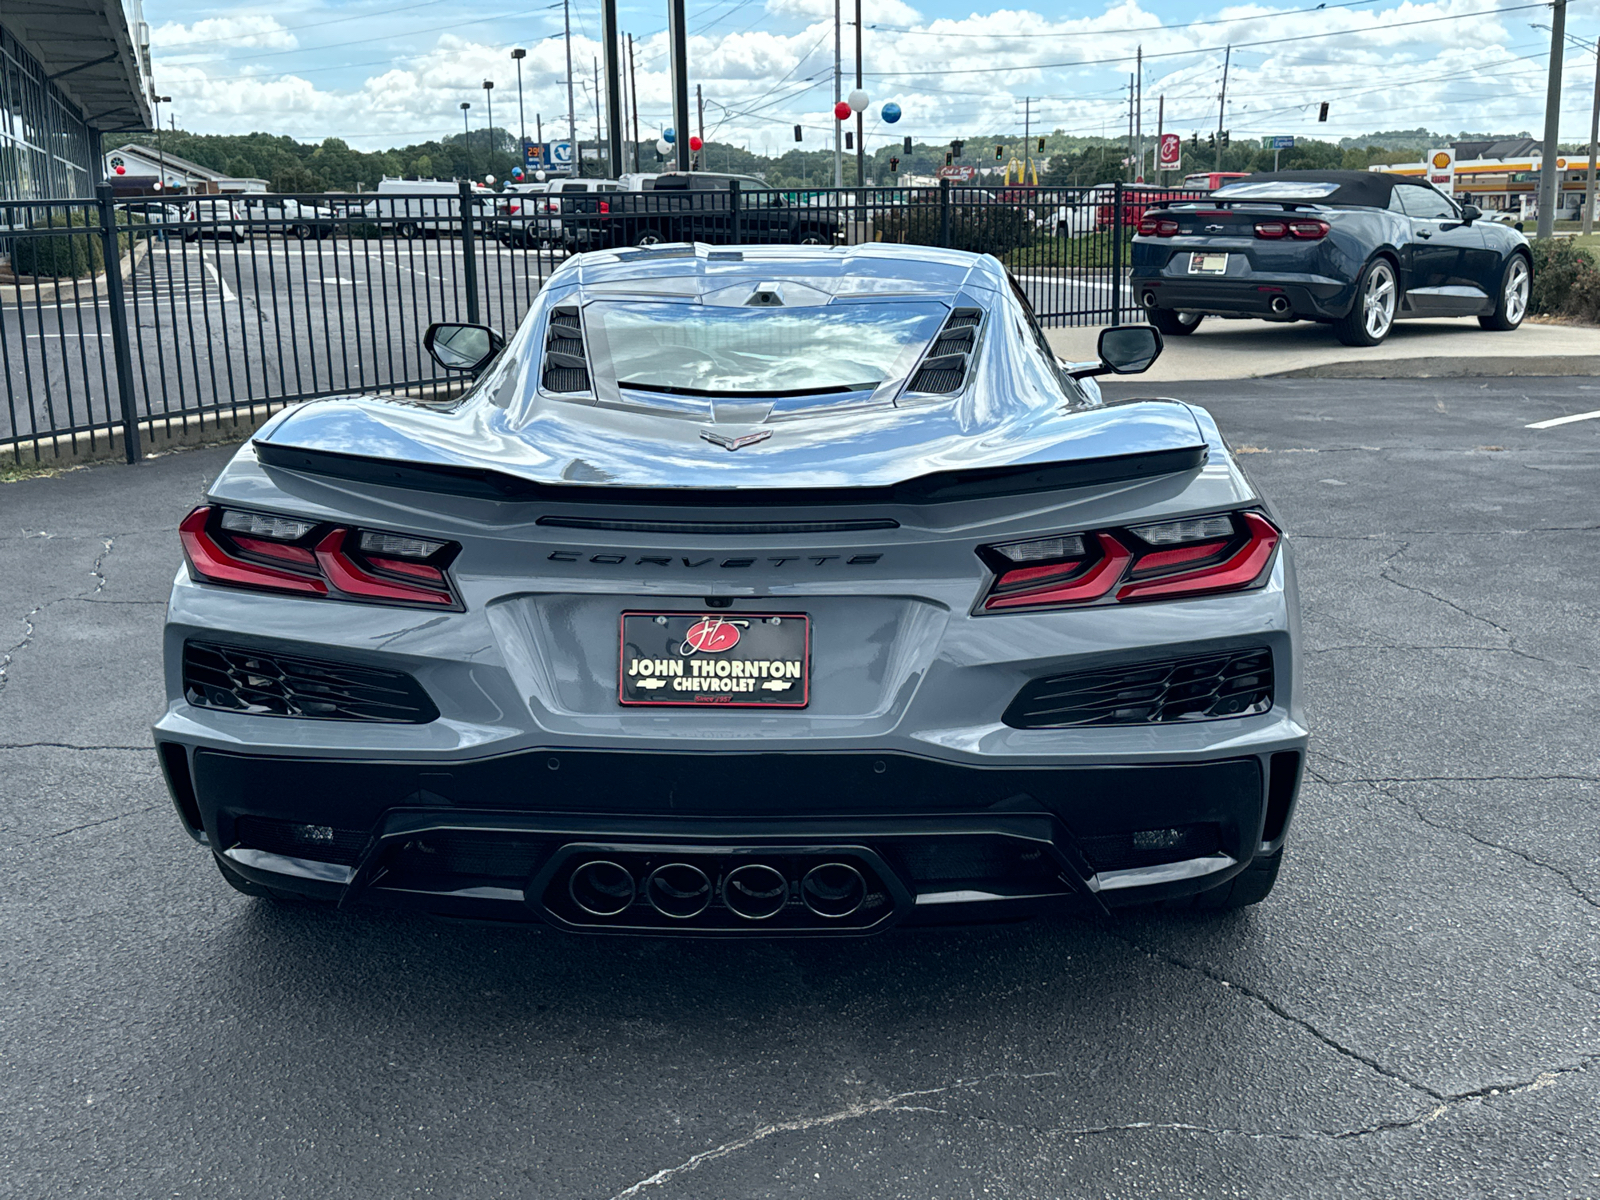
<box><xmin>162</xmin><ymin>741</ymin><xmax>1304</xmax><ymax>936</ymax></box>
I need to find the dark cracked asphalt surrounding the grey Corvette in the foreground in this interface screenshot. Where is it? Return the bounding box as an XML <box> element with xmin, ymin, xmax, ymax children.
<box><xmin>0</xmin><ymin>378</ymin><xmax>1600</xmax><ymax>1200</ymax></box>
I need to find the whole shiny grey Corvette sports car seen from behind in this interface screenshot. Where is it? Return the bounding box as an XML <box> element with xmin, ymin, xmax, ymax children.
<box><xmin>155</xmin><ymin>245</ymin><xmax>1307</xmax><ymax>936</ymax></box>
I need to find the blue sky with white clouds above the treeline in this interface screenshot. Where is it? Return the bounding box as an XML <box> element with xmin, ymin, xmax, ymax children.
<box><xmin>144</xmin><ymin>0</ymin><xmax>1600</xmax><ymax>154</ymax></box>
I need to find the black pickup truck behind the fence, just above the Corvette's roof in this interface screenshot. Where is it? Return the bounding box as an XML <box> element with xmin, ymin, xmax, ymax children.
<box><xmin>562</xmin><ymin>171</ymin><xmax>843</xmax><ymax>251</ymax></box>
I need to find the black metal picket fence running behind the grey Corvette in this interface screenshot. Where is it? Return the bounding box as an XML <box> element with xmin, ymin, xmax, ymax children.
<box><xmin>0</xmin><ymin>178</ymin><xmax>1194</xmax><ymax>462</ymax></box>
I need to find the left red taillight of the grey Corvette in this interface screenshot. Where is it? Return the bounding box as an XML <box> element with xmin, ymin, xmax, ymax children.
<box><xmin>178</xmin><ymin>506</ymin><xmax>461</xmax><ymax>610</ymax></box>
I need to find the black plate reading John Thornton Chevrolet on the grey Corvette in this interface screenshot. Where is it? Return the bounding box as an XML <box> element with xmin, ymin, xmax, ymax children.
<box><xmin>616</xmin><ymin>613</ymin><xmax>811</xmax><ymax>709</ymax></box>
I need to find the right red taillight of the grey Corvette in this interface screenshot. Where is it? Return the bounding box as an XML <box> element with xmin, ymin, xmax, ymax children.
<box><xmin>978</xmin><ymin>512</ymin><xmax>1283</xmax><ymax>613</ymax></box>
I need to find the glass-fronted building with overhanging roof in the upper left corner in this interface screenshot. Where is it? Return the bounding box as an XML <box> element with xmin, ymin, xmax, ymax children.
<box><xmin>0</xmin><ymin>0</ymin><xmax>154</xmax><ymax>202</ymax></box>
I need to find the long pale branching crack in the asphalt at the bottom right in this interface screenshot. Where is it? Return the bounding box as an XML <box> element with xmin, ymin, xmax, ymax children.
<box><xmin>610</xmin><ymin>1056</ymin><xmax>1600</xmax><ymax>1200</ymax></box>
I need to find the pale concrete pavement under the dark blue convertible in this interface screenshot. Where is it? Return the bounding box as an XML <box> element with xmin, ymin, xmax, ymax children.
<box><xmin>1046</xmin><ymin>317</ymin><xmax>1600</xmax><ymax>382</ymax></box>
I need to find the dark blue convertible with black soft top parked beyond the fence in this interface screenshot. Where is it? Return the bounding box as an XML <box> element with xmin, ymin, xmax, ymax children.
<box><xmin>1133</xmin><ymin>171</ymin><xmax>1533</xmax><ymax>346</ymax></box>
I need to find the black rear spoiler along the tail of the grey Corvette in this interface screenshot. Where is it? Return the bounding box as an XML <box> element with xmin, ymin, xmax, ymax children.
<box><xmin>253</xmin><ymin>442</ymin><xmax>1208</xmax><ymax>509</ymax></box>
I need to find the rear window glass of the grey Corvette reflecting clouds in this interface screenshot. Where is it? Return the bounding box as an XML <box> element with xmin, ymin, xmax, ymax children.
<box><xmin>584</xmin><ymin>302</ymin><xmax>949</xmax><ymax>397</ymax></box>
